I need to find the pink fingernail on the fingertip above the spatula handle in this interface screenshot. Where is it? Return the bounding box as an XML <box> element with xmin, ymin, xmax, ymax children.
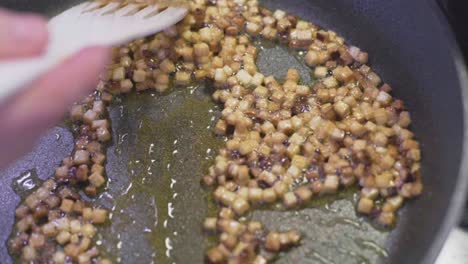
<box><xmin>11</xmin><ymin>15</ymin><xmax>47</xmax><ymax>44</ymax></box>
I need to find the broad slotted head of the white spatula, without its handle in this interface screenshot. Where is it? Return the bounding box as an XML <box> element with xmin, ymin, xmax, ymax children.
<box><xmin>49</xmin><ymin>1</ymin><xmax>187</xmax><ymax>50</ymax></box>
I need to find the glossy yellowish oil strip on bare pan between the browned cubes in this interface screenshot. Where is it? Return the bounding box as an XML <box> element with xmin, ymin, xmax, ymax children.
<box><xmin>94</xmin><ymin>85</ymin><xmax>222</xmax><ymax>263</ymax></box>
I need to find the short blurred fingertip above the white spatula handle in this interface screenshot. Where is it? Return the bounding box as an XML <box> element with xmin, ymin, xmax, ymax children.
<box><xmin>0</xmin><ymin>9</ymin><xmax>48</xmax><ymax>59</ymax></box>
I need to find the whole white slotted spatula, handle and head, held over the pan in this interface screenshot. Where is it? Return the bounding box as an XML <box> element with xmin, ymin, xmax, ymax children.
<box><xmin>0</xmin><ymin>1</ymin><xmax>187</xmax><ymax>102</ymax></box>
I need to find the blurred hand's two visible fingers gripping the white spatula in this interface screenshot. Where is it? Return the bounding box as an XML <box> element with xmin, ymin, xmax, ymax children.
<box><xmin>0</xmin><ymin>9</ymin><xmax>110</xmax><ymax>169</ymax></box>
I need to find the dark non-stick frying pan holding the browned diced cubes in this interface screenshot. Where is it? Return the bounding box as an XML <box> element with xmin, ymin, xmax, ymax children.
<box><xmin>0</xmin><ymin>0</ymin><xmax>468</xmax><ymax>263</ymax></box>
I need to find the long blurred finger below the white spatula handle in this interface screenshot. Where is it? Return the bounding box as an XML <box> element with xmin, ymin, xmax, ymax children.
<box><xmin>0</xmin><ymin>48</ymin><xmax>110</xmax><ymax>167</ymax></box>
